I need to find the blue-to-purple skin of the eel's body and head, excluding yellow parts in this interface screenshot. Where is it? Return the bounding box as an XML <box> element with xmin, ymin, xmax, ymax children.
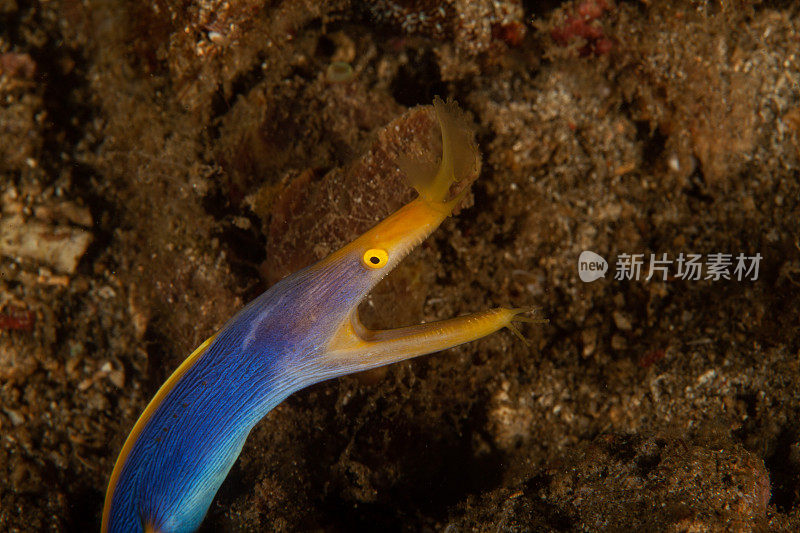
<box><xmin>109</xmin><ymin>255</ymin><xmax>368</xmax><ymax>533</ymax></box>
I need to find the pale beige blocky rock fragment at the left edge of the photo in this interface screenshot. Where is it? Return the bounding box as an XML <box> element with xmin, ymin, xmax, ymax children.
<box><xmin>0</xmin><ymin>209</ymin><xmax>92</xmax><ymax>274</ymax></box>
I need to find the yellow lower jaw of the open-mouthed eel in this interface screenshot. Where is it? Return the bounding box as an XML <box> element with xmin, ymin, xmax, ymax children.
<box><xmin>322</xmin><ymin>308</ymin><xmax>529</xmax><ymax>372</ymax></box>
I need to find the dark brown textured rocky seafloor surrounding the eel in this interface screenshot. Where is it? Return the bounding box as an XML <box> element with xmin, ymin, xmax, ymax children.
<box><xmin>0</xmin><ymin>0</ymin><xmax>800</xmax><ymax>531</ymax></box>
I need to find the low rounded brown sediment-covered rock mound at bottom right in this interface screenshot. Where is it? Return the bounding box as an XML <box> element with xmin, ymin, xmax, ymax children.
<box><xmin>447</xmin><ymin>434</ymin><xmax>770</xmax><ymax>531</ymax></box>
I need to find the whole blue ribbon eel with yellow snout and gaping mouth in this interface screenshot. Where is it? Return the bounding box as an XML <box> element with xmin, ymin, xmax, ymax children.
<box><xmin>102</xmin><ymin>99</ymin><xmax>528</xmax><ymax>533</ymax></box>
